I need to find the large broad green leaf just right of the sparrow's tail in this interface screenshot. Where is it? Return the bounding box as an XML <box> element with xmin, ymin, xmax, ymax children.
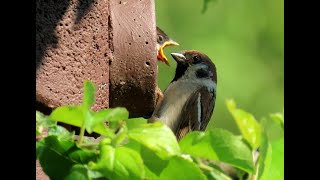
<box><xmin>179</xmin><ymin>129</ymin><xmax>254</xmax><ymax>173</ymax></box>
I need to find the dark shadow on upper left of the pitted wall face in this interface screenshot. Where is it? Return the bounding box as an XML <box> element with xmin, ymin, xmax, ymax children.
<box><xmin>36</xmin><ymin>0</ymin><xmax>96</xmax><ymax>69</ymax></box>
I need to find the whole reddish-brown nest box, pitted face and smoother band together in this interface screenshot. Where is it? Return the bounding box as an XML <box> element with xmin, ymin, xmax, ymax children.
<box><xmin>36</xmin><ymin>0</ymin><xmax>158</xmax><ymax>117</ymax></box>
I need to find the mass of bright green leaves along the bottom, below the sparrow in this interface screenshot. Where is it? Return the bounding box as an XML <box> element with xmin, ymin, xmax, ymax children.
<box><xmin>36</xmin><ymin>81</ymin><xmax>284</xmax><ymax>179</ymax></box>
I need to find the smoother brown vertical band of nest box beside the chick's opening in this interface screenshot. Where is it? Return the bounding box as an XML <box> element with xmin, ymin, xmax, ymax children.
<box><xmin>110</xmin><ymin>0</ymin><xmax>158</xmax><ymax>117</ymax></box>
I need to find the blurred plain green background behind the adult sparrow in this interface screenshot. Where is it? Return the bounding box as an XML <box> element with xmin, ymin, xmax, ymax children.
<box><xmin>155</xmin><ymin>0</ymin><xmax>284</xmax><ymax>133</ymax></box>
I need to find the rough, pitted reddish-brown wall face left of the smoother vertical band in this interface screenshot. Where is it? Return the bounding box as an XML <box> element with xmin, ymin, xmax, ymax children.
<box><xmin>36</xmin><ymin>0</ymin><xmax>110</xmax><ymax>109</ymax></box>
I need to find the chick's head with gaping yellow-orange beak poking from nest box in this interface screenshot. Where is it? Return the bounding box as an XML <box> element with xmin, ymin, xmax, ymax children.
<box><xmin>157</xmin><ymin>27</ymin><xmax>179</xmax><ymax>65</ymax></box>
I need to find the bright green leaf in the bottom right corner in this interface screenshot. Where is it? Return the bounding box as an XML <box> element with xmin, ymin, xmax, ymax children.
<box><xmin>259</xmin><ymin>137</ymin><xmax>284</xmax><ymax>180</ymax></box>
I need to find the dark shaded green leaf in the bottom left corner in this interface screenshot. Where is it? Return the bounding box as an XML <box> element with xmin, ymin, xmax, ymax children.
<box><xmin>39</xmin><ymin>136</ymin><xmax>75</xmax><ymax>179</ymax></box>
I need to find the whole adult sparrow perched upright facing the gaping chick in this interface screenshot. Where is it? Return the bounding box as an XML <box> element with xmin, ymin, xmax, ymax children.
<box><xmin>149</xmin><ymin>50</ymin><xmax>217</xmax><ymax>140</ymax></box>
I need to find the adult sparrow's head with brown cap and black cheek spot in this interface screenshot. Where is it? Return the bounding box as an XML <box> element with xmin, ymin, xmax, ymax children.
<box><xmin>171</xmin><ymin>50</ymin><xmax>217</xmax><ymax>84</ymax></box>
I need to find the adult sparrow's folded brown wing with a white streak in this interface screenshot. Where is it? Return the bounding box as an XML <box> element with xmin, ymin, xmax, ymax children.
<box><xmin>175</xmin><ymin>87</ymin><xmax>216</xmax><ymax>140</ymax></box>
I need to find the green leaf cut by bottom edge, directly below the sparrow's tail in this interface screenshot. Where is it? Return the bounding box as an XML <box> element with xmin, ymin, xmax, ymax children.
<box><xmin>160</xmin><ymin>156</ymin><xmax>207</xmax><ymax>180</ymax></box>
